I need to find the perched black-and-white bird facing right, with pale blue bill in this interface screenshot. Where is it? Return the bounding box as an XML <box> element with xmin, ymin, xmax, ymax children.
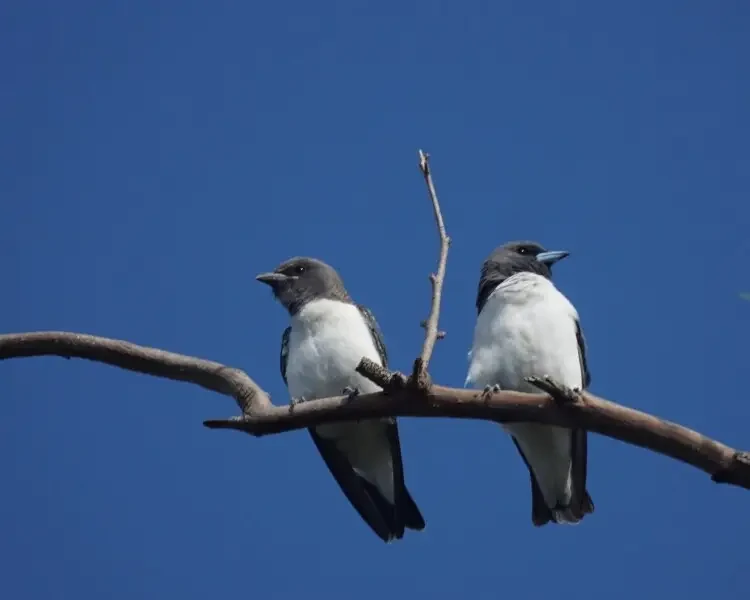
<box><xmin>466</xmin><ymin>242</ymin><xmax>594</xmax><ymax>526</ymax></box>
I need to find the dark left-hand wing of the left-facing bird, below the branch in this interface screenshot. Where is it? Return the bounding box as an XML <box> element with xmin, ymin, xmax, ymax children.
<box><xmin>308</xmin><ymin>427</ymin><xmax>404</xmax><ymax>542</ymax></box>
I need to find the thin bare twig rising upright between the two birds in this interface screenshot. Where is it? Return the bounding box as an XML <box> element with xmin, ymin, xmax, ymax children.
<box><xmin>412</xmin><ymin>150</ymin><xmax>451</xmax><ymax>389</ymax></box>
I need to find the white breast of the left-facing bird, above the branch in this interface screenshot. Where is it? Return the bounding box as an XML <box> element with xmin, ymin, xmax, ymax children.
<box><xmin>286</xmin><ymin>300</ymin><xmax>381</xmax><ymax>400</ymax></box>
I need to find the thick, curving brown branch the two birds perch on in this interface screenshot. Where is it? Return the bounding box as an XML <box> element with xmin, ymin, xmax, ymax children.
<box><xmin>0</xmin><ymin>331</ymin><xmax>750</xmax><ymax>489</ymax></box>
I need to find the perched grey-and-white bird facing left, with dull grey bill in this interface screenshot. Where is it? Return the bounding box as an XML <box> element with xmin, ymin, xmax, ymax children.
<box><xmin>256</xmin><ymin>257</ymin><xmax>425</xmax><ymax>542</ymax></box>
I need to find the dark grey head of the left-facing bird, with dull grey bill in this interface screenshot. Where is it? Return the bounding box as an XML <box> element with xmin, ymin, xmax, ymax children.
<box><xmin>255</xmin><ymin>256</ymin><xmax>351</xmax><ymax>315</ymax></box>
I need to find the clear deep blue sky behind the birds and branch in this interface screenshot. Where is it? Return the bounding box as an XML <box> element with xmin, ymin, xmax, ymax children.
<box><xmin>0</xmin><ymin>0</ymin><xmax>750</xmax><ymax>600</ymax></box>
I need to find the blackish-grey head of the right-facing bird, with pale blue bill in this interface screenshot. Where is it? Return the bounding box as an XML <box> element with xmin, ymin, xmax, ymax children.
<box><xmin>477</xmin><ymin>242</ymin><xmax>569</xmax><ymax>312</ymax></box>
